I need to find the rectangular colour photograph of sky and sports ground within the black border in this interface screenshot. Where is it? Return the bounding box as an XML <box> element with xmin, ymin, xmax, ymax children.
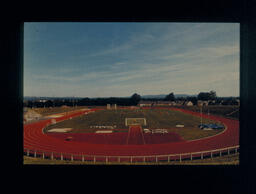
<box><xmin>22</xmin><ymin>22</ymin><xmax>240</xmax><ymax>164</ymax></box>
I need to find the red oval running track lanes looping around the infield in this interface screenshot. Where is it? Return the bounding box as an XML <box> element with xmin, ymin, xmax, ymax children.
<box><xmin>24</xmin><ymin>108</ymin><xmax>239</xmax><ymax>156</ymax></box>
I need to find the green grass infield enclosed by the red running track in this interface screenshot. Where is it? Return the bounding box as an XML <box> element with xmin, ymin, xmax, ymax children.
<box><xmin>44</xmin><ymin>109</ymin><xmax>223</xmax><ymax>140</ymax></box>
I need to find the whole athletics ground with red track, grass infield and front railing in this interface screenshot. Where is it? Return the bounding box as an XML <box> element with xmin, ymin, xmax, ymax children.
<box><xmin>23</xmin><ymin>106</ymin><xmax>239</xmax><ymax>164</ymax></box>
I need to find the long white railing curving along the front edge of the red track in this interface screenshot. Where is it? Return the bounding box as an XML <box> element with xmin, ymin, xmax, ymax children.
<box><xmin>24</xmin><ymin>145</ymin><xmax>240</xmax><ymax>163</ymax></box>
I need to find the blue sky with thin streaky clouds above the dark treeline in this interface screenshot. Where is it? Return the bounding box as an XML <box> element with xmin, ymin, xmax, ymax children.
<box><xmin>24</xmin><ymin>22</ymin><xmax>240</xmax><ymax>97</ymax></box>
